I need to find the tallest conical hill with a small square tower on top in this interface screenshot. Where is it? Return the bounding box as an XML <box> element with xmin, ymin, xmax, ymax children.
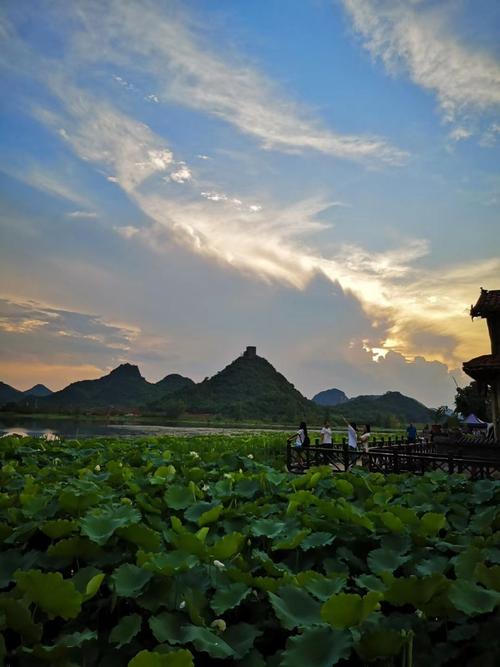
<box><xmin>157</xmin><ymin>348</ymin><xmax>320</xmax><ymax>421</ymax></box>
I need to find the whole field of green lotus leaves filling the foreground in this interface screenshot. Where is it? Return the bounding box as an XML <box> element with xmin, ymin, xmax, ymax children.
<box><xmin>0</xmin><ymin>434</ymin><xmax>500</xmax><ymax>667</ymax></box>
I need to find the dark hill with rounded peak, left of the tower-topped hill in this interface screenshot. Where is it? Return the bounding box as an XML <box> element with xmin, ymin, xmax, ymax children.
<box><xmin>26</xmin><ymin>364</ymin><xmax>161</xmax><ymax>410</ymax></box>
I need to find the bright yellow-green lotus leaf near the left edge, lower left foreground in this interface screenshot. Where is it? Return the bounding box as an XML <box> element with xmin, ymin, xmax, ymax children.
<box><xmin>14</xmin><ymin>570</ymin><xmax>83</xmax><ymax>620</ymax></box>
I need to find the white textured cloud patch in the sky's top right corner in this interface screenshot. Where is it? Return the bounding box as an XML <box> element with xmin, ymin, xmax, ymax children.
<box><xmin>342</xmin><ymin>0</ymin><xmax>500</xmax><ymax>131</ymax></box>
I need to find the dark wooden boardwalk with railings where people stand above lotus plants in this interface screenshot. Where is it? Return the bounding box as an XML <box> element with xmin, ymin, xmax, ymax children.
<box><xmin>286</xmin><ymin>439</ymin><xmax>500</xmax><ymax>479</ymax></box>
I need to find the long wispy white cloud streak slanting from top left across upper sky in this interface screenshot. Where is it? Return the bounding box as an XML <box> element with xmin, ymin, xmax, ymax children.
<box><xmin>68</xmin><ymin>1</ymin><xmax>408</xmax><ymax>165</ymax></box>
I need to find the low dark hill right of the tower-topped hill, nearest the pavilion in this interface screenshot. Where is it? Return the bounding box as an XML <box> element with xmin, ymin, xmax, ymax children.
<box><xmin>331</xmin><ymin>391</ymin><xmax>434</xmax><ymax>426</ymax></box>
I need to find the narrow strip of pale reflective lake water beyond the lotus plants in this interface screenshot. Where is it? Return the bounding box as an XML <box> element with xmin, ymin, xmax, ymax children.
<box><xmin>0</xmin><ymin>417</ymin><xmax>282</xmax><ymax>439</ymax></box>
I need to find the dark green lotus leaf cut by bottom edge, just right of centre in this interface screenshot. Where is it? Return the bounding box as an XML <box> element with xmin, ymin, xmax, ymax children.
<box><xmin>280</xmin><ymin>625</ymin><xmax>353</xmax><ymax>667</ymax></box>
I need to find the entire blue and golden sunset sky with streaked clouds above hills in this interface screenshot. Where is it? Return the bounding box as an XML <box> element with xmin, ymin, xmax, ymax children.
<box><xmin>0</xmin><ymin>0</ymin><xmax>500</xmax><ymax>407</ymax></box>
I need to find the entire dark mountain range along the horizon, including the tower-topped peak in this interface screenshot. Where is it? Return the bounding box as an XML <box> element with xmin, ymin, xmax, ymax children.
<box><xmin>0</xmin><ymin>347</ymin><xmax>433</xmax><ymax>425</ymax></box>
